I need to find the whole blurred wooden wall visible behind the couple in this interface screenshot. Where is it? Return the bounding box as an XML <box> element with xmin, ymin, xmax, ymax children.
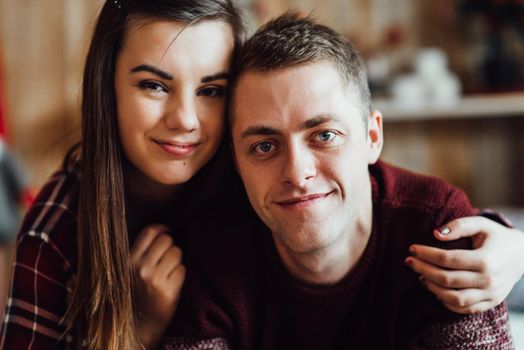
<box><xmin>0</xmin><ymin>0</ymin><xmax>524</xmax><ymax>206</ymax></box>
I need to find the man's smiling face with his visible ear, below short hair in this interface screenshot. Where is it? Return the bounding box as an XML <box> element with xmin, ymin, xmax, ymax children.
<box><xmin>232</xmin><ymin>62</ymin><xmax>382</xmax><ymax>253</ymax></box>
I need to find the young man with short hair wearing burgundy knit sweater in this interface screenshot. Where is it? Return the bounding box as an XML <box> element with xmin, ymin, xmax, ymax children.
<box><xmin>165</xmin><ymin>15</ymin><xmax>513</xmax><ymax>349</ymax></box>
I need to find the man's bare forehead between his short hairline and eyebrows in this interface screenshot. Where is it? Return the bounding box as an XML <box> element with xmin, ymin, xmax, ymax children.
<box><xmin>231</xmin><ymin>62</ymin><xmax>361</xmax><ymax>124</ymax></box>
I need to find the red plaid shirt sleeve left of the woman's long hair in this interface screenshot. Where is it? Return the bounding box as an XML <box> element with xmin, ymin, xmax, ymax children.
<box><xmin>0</xmin><ymin>159</ymin><xmax>80</xmax><ymax>349</ymax></box>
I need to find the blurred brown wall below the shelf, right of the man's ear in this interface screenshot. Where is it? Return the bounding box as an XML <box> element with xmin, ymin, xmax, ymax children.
<box><xmin>382</xmin><ymin>116</ymin><xmax>524</xmax><ymax>208</ymax></box>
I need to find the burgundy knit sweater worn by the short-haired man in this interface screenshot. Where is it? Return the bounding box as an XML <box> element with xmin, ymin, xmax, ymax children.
<box><xmin>163</xmin><ymin>162</ymin><xmax>513</xmax><ymax>350</ymax></box>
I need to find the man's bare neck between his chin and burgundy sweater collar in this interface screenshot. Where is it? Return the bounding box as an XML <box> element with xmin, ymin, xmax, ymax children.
<box><xmin>276</xmin><ymin>182</ymin><xmax>373</xmax><ymax>285</ymax></box>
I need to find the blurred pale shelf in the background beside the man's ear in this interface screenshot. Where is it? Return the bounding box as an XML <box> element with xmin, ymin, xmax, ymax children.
<box><xmin>373</xmin><ymin>92</ymin><xmax>524</xmax><ymax>122</ymax></box>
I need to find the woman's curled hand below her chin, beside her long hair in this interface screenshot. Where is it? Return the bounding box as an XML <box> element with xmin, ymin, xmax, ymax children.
<box><xmin>131</xmin><ymin>225</ymin><xmax>186</xmax><ymax>349</ymax></box>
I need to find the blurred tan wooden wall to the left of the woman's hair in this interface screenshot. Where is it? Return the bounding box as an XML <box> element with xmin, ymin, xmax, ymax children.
<box><xmin>0</xmin><ymin>0</ymin><xmax>103</xmax><ymax>187</ymax></box>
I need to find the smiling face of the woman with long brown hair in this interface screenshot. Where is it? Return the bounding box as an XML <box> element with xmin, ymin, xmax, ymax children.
<box><xmin>115</xmin><ymin>20</ymin><xmax>233</xmax><ymax>185</ymax></box>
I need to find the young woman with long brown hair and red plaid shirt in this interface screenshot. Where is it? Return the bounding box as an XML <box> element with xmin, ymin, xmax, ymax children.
<box><xmin>0</xmin><ymin>0</ymin><xmax>524</xmax><ymax>349</ymax></box>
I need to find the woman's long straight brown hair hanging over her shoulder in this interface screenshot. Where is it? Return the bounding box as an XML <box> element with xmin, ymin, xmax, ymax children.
<box><xmin>65</xmin><ymin>0</ymin><xmax>243</xmax><ymax>350</ymax></box>
